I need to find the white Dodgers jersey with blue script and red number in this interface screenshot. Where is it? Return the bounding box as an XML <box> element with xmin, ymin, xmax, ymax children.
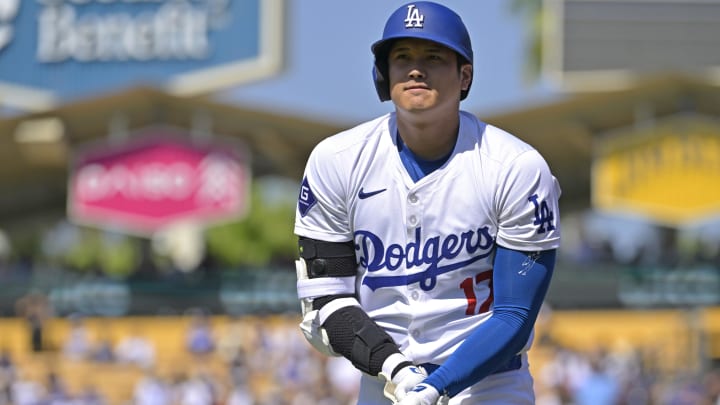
<box><xmin>295</xmin><ymin>112</ymin><xmax>560</xmax><ymax>364</ymax></box>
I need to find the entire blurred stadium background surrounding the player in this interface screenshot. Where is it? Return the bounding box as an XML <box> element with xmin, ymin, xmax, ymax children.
<box><xmin>0</xmin><ymin>0</ymin><xmax>720</xmax><ymax>405</ymax></box>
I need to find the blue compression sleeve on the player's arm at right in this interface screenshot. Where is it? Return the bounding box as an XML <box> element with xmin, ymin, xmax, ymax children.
<box><xmin>424</xmin><ymin>246</ymin><xmax>555</xmax><ymax>397</ymax></box>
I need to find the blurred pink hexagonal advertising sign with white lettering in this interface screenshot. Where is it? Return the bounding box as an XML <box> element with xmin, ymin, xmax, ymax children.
<box><xmin>68</xmin><ymin>127</ymin><xmax>250</xmax><ymax>235</ymax></box>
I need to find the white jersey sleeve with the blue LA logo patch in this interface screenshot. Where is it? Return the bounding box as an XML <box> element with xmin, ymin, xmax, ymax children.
<box><xmin>495</xmin><ymin>149</ymin><xmax>561</xmax><ymax>251</ymax></box>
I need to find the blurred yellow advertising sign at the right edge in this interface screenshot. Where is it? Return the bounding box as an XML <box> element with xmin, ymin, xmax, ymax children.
<box><xmin>592</xmin><ymin>116</ymin><xmax>720</xmax><ymax>225</ymax></box>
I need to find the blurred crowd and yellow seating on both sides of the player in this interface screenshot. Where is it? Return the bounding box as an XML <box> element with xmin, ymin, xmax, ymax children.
<box><xmin>0</xmin><ymin>311</ymin><xmax>720</xmax><ymax>405</ymax></box>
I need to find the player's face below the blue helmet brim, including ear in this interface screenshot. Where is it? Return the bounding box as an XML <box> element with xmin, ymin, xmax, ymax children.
<box><xmin>388</xmin><ymin>39</ymin><xmax>472</xmax><ymax>111</ymax></box>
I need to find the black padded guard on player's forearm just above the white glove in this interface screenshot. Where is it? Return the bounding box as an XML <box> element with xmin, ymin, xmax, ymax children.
<box><xmin>323</xmin><ymin>307</ymin><xmax>400</xmax><ymax>376</ymax></box>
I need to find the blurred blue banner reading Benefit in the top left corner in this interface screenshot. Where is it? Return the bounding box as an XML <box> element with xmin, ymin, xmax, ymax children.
<box><xmin>0</xmin><ymin>0</ymin><xmax>284</xmax><ymax>109</ymax></box>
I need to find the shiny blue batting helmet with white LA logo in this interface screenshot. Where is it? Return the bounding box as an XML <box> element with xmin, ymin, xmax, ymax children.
<box><xmin>371</xmin><ymin>1</ymin><xmax>473</xmax><ymax>101</ymax></box>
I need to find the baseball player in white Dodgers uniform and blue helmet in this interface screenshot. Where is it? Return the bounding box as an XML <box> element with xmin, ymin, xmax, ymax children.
<box><xmin>295</xmin><ymin>1</ymin><xmax>560</xmax><ymax>405</ymax></box>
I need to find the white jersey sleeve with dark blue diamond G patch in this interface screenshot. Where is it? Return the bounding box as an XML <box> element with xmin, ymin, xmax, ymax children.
<box><xmin>295</xmin><ymin>140</ymin><xmax>352</xmax><ymax>242</ymax></box>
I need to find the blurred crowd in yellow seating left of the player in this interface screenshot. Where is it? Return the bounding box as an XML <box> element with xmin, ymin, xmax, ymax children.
<box><xmin>0</xmin><ymin>312</ymin><xmax>358</xmax><ymax>405</ymax></box>
